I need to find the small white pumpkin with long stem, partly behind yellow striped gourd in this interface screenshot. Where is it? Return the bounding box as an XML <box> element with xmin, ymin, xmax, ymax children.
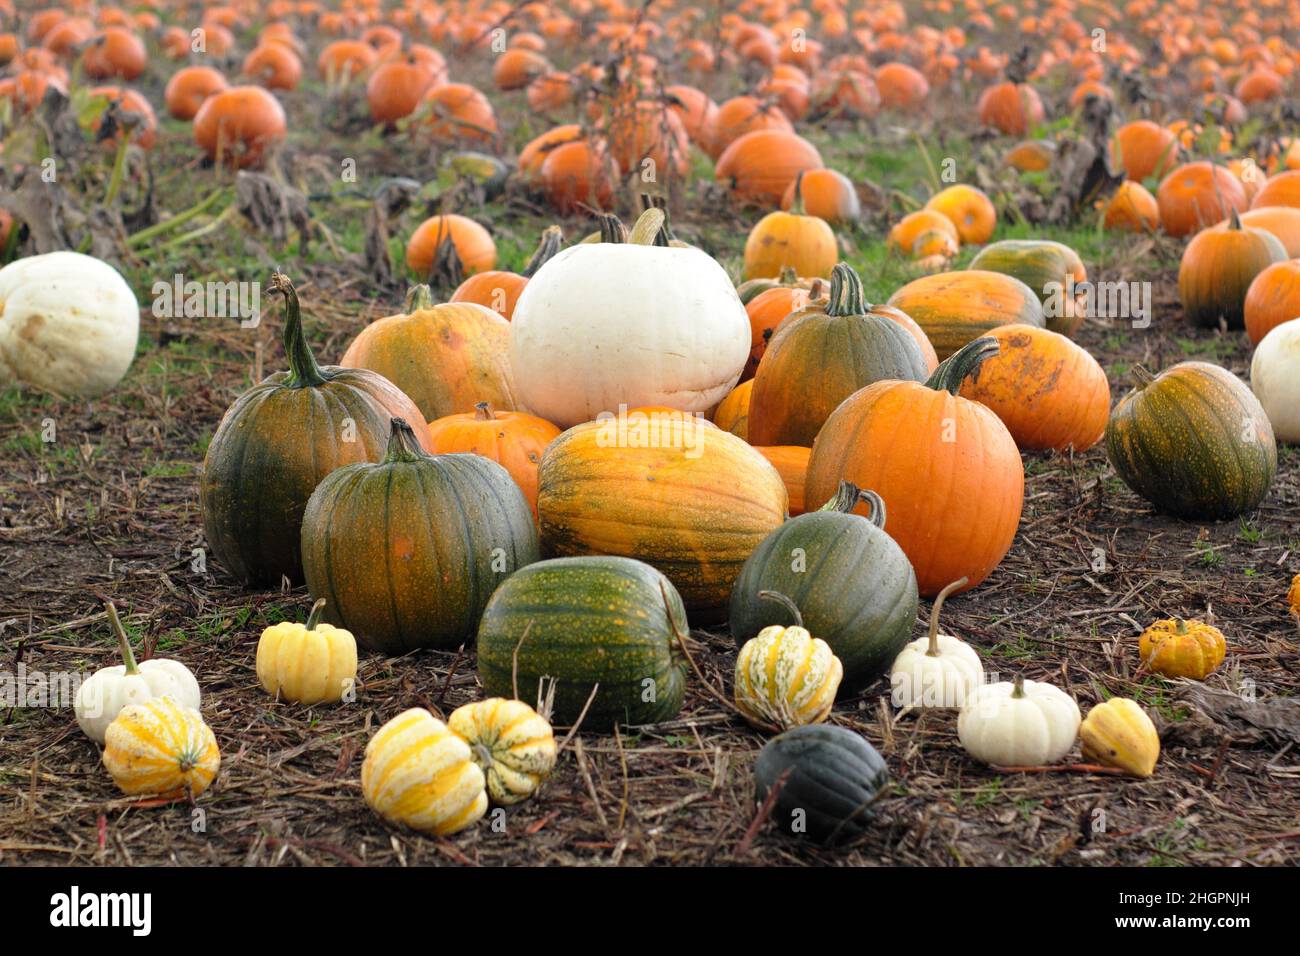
<box><xmin>73</xmin><ymin>602</ymin><xmax>200</xmax><ymax>744</ymax></box>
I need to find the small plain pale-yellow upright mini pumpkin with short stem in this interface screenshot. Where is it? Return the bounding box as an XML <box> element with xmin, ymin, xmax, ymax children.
<box><xmin>257</xmin><ymin>598</ymin><xmax>356</xmax><ymax>704</ymax></box>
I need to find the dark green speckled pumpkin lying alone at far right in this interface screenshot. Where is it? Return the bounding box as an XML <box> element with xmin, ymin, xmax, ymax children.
<box><xmin>1106</xmin><ymin>362</ymin><xmax>1278</xmax><ymax>519</ymax></box>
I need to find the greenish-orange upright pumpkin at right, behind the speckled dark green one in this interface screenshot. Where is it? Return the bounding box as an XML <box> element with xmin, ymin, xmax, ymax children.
<box><xmin>1178</xmin><ymin>209</ymin><xmax>1287</xmax><ymax>329</ymax></box>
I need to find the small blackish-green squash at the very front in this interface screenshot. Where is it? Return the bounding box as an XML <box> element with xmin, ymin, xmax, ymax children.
<box><xmin>754</xmin><ymin>723</ymin><xmax>889</xmax><ymax>844</ymax></box>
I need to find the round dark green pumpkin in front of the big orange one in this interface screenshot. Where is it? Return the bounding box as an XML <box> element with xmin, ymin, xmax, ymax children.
<box><xmin>731</xmin><ymin>481</ymin><xmax>917</xmax><ymax>687</ymax></box>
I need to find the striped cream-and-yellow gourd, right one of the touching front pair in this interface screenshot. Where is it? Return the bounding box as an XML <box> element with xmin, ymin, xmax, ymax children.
<box><xmin>447</xmin><ymin>697</ymin><xmax>555</xmax><ymax>806</ymax></box>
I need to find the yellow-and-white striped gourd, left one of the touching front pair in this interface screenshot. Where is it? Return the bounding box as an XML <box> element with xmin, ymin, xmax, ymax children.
<box><xmin>361</xmin><ymin>708</ymin><xmax>488</xmax><ymax>836</ymax></box>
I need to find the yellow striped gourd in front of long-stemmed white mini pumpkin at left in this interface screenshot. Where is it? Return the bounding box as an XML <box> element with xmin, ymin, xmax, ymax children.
<box><xmin>104</xmin><ymin>697</ymin><xmax>221</xmax><ymax>797</ymax></box>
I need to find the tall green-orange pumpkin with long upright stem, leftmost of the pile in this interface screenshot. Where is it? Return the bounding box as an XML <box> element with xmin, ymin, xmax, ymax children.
<box><xmin>199</xmin><ymin>273</ymin><xmax>424</xmax><ymax>587</ymax></box>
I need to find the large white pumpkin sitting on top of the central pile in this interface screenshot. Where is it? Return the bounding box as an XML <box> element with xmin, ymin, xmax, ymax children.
<box><xmin>510</xmin><ymin>209</ymin><xmax>750</xmax><ymax>428</ymax></box>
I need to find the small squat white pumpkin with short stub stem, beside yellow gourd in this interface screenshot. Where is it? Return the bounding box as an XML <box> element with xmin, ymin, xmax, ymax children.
<box><xmin>957</xmin><ymin>676</ymin><xmax>1080</xmax><ymax>767</ymax></box>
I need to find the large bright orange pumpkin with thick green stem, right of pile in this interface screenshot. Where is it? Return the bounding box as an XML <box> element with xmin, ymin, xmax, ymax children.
<box><xmin>805</xmin><ymin>338</ymin><xmax>1024</xmax><ymax>597</ymax></box>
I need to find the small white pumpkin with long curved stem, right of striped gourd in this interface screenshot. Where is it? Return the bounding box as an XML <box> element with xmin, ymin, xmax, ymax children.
<box><xmin>889</xmin><ymin>578</ymin><xmax>984</xmax><ymax>709</ymax></box>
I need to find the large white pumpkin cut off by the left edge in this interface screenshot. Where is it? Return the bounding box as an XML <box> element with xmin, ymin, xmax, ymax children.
<box><xmin>0</xmin><ymin>252</ymin><xmax>140</xmax><ymax>395</ymax></box>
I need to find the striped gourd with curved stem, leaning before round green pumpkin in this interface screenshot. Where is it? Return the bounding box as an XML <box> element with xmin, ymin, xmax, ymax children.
<box><xmin>735</xmin><ymin>591</ymin><xmax>844</xmax><ymax>731</ymax></box>
